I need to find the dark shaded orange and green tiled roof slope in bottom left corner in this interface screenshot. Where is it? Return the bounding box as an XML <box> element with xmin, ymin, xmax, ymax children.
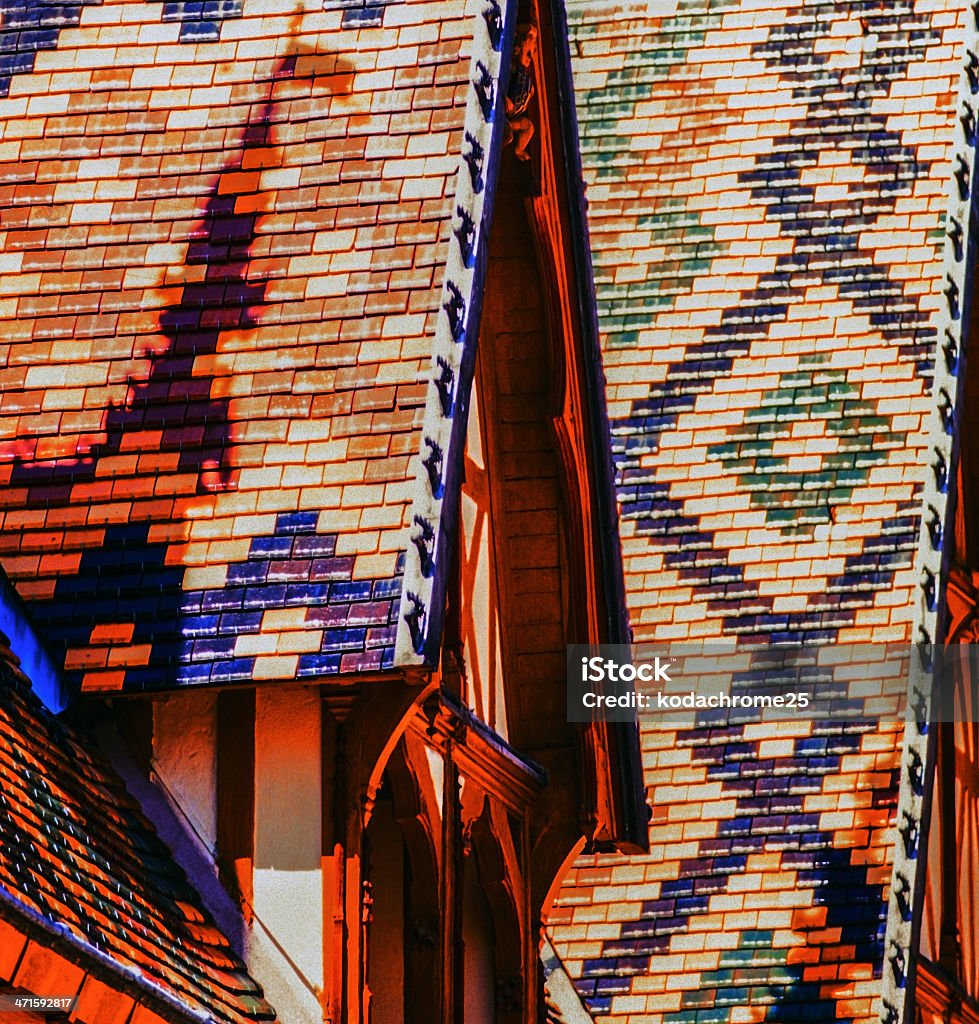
<box><xmin>0</xmin><ymin>634</ymin><xmax>275</xmax><ymax>1024</ymax></box>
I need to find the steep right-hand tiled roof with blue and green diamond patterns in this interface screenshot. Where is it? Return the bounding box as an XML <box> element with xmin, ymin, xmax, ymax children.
<box><xmin>550</xmin><ymin>0</ymin><xmax>971</xmax><ymax>1024</ymax></box>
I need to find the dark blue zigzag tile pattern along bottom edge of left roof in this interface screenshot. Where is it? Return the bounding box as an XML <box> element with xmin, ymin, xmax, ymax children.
<box><xmin>25</xmin><ymin>512</ymin><xmax>401</xmax><ymax>690</ymax></box>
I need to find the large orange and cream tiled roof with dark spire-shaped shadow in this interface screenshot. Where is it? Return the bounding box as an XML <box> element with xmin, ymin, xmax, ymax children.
<box><xmin>0</xmin><ymin>0</ymin><xmax>502</xmax><ymax>690</ymax></box>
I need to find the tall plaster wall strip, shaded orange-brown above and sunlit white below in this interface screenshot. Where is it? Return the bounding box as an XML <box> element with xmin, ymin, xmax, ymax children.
<box><xmin>247</xmin><ymin>686</ymin><xmax>324</xmax><ymax>1024</ymax></box>
